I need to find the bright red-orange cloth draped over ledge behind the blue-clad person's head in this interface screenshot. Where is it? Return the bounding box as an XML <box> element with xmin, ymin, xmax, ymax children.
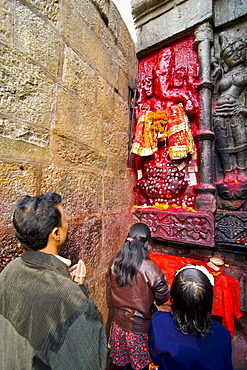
<box><xmin>149</xmin><ymin>253</ymin><xmax>242</xmax><ymax>337</ymax></box>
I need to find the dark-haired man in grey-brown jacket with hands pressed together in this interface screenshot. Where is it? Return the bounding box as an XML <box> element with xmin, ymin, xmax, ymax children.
<box><xmin>0</xmin><ymin>192</ymin><xmax>107</xmax><ymax>370</ymax></box>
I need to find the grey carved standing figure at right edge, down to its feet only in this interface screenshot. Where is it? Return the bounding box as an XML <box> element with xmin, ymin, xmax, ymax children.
<box><xmin>212</xmin><ymin>32</ymin><xmax>247</xmax><ymax>184</ymax></box>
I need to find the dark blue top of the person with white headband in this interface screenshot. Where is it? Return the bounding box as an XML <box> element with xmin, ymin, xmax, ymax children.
<box><xmin>148</xmin><ymin>311</ymin><xmax>233</xmax><ymax>370</ymax></box>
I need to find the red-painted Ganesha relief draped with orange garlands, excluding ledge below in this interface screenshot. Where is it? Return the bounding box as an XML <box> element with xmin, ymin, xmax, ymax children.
<box><xmin>132</xmin><ymin>37</ymin><xmax>199</xmax><ymax>207</ymax></box>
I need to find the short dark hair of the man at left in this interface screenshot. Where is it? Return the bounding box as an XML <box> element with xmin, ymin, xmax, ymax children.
<box><xmin>13</xmin><ymin>192</ymin><xmax>61</xmax><ymax>250</ymax></box>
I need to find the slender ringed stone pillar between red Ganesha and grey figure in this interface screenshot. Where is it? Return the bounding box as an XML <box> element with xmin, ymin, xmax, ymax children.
<box><xmin>195</xmin><ymin>23</ymin><xmax>216</xmax><ymax>212</ymax></box>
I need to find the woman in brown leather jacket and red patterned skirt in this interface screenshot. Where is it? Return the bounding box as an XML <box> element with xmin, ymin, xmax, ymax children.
<box><xmin>108</xmin><ymin>223</ymin><xmax>170</xmax><ymax>370</ymax></box>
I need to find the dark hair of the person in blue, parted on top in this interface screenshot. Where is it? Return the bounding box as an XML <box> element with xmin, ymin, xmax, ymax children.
<box><xmin>171</xmin><ymin>268</ymin><xmax>213</xmax><ymax>336</ymax></box>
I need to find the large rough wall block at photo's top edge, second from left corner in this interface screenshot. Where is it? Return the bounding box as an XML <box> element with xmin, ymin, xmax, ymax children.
<box><xmin>14</xmin><ymin>1</ymin><xmax>59</xmax><ymax>76</ymax></box>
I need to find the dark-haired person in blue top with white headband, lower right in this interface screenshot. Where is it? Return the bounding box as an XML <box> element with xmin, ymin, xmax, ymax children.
<box><xmin>148</xmin><ymin>264</ymin><xmax>233</xmax><ymax>370</ymax></box>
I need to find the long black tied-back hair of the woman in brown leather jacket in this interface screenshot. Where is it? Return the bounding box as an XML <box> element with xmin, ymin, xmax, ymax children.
<box><xmin>114</xmin><ymin>223</ymin><xmax>151</xmax><ymax>287</ymax></box>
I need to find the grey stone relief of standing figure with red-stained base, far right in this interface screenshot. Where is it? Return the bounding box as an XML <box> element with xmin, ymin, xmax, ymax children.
<box><xmin>212</xmin><ymin>31</ymin><xmax>247</xmax><ymax>210</ymax></box>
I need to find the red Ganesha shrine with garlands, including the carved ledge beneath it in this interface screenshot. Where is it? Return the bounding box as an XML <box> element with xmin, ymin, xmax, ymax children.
<box><xmin>131</xmin><ymin>37</ymin><xmax>214</xmax><ymax>246</ymax></box>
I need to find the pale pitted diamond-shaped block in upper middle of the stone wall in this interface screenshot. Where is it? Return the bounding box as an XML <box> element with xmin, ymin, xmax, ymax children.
<box><xmin>62</xmin><ymin>46</ymin><xmax>96</xmax><ymax>104</ymax></box>
